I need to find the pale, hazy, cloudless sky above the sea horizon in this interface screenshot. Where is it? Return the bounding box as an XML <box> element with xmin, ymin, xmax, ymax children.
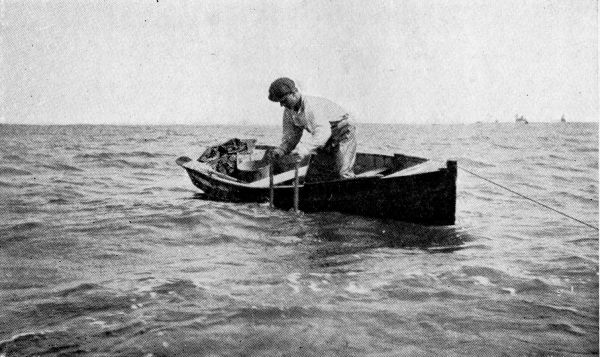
<box><xmin>0</xmin><ymin>0</ymin><xmax>598</xmax><ymax>125</ymax></box>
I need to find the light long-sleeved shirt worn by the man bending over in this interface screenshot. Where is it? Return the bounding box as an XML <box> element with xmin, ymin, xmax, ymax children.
<box><xmin>279</xmin><ymin>95</ymin><xmax>349</xmax><ymax>154</ymax></box>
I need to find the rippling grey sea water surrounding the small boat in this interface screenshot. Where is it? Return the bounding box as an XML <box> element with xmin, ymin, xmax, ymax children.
<box><xmin>0</xmin><ymin>123</ymin><xmax>598</xmax><ymax>356</ymax></box>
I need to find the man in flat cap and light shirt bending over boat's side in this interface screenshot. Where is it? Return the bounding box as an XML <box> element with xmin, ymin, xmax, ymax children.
<box><xmin>269</xmin><ymin>77</ymin><xmax>356</xmax><ymax>182</ymax></box>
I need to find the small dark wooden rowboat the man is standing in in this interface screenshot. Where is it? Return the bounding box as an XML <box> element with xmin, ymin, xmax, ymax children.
<box><xmin>176</xmin><ymin>140</ymin><xmax>457</xmax><ymax>225</ymax></box>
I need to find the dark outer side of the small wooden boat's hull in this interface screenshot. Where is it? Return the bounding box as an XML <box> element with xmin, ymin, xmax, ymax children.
<box><xmin>180</xmin><ymin>156</ymin><xmax>456</xmax><ymax>225</ymax></box>
